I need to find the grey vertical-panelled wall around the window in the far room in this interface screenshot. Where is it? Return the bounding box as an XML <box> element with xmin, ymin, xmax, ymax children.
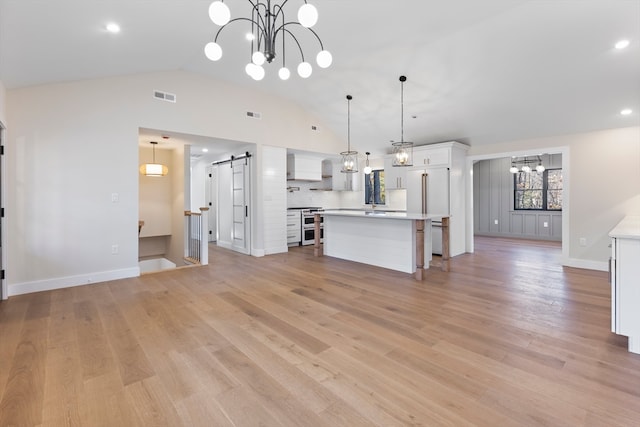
<box><xmin>473</xmin><ymin>154</ymin><xmax>562</xmax><ymax>241</ymax></box>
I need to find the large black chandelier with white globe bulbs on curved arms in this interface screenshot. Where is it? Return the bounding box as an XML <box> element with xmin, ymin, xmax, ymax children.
<box><xmin>204</xmin><ymin>0</ymin><xmax>333</xmax><ymax>80</ymax></box>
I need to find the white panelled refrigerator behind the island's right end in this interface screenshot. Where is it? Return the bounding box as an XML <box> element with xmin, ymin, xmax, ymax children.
<box><xmin>407</xmin><ymin>167</ymin><xmax>451</xmax><ymax>255</ymax></box>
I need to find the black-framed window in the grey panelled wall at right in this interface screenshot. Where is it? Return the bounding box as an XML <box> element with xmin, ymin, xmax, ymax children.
<box><xmin>513</xmin><ymin>169</ymin><xmax>562</xmax><ymax>211</ymax></box>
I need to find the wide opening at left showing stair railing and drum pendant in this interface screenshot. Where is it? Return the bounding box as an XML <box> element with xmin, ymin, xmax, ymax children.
<box><xmin>138</xmin><ymin>128</ymin><xmax>255</xmax><ymax>272</ymax></box>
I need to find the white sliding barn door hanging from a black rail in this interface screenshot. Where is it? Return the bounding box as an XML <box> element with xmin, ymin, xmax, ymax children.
<box><xmin>231</xmin><ymin>158</ymin><xmax>251</xmax><ymax>254</ymax></box>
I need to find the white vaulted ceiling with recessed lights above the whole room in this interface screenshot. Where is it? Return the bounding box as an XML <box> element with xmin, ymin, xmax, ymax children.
<box><xmin>0</xmin><ymin>0</ymin><xmax>640</xmax><ymax>152</ymax></box>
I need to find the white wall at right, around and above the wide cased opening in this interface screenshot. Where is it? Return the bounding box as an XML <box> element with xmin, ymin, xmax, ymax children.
<box><xmin>469</xmin><ymin>127</ymin><xmax>640</xmax><ymax>270</ymax></box>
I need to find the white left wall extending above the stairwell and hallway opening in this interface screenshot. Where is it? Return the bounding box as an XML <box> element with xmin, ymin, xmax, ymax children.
<box><xmin>6</xmin><ymin>71</ymin><xmax>343</xmax><ymax>295</ymax></box>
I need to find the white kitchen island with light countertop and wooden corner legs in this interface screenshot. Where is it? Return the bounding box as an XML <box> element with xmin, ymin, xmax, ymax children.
<box><xmin>316</xmin><ymin>210</ymin><xmax>448</xmax><ymax>280</ymax></box>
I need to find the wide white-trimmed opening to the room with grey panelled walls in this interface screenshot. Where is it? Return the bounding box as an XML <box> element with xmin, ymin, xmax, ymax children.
<box><xmin>467</xmin><ymin>147</ymin><xmax>570</xmax><ymax>259</ymax></box>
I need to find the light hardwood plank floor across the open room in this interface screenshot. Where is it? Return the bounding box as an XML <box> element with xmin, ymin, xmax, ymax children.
<box><xmin>0</xmin><ymin>238</ymin><xmax>640</xmax><ymax>427</ymax></box>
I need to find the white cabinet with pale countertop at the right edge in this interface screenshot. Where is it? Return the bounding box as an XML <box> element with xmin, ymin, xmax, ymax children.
<box><xmin>609</xmin><ymin>216</ymin><xmax>640</xmax><ymax>354</ymax></box>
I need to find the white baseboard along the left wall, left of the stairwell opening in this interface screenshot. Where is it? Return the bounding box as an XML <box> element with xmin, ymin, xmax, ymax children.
<box><xmin>8</xmin><ymin>267</ymin><xmax>140</xmax><ymax>297</ymax></box>
